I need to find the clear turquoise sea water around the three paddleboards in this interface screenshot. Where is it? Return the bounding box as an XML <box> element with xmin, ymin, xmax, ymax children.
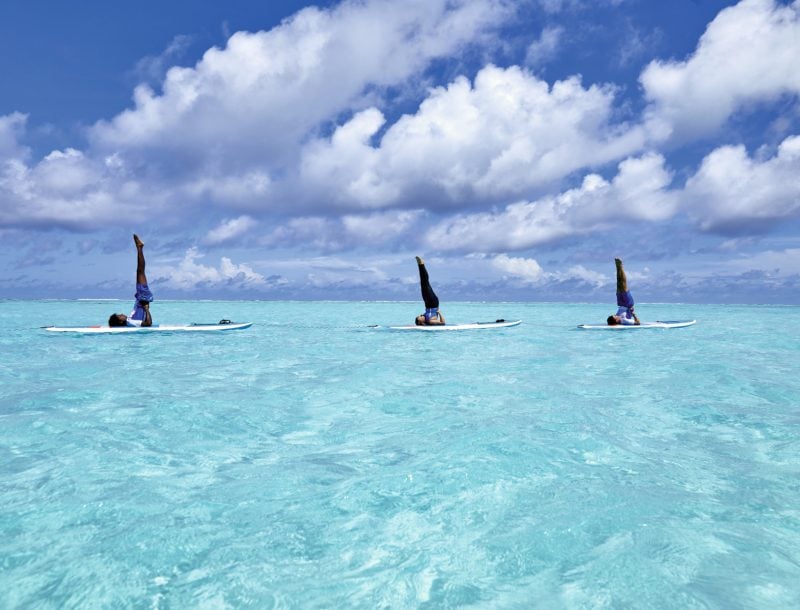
<box><xmin>0</xmin><ymin>301</ymin><xmax>800</xmax><ymax>609</ymax></box>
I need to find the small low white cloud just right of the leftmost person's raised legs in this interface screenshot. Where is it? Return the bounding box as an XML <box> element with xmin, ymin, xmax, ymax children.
<box><xmin>153</xmin><ymin>248</ymin><xmax>266</xmax><ymax>290</ymax></box>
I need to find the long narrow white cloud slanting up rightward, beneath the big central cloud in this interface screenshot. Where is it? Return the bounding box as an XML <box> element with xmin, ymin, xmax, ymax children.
<box><xmin>425</xmin><ymin>153</ymin><xmax>678</xmax><ymax>252</ymax></box>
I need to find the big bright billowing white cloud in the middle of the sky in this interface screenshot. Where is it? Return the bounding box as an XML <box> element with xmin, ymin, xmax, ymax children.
<box><xmin>300</xmin><ymin>66</ymin><xmax>644</xmax><ymax>207</ymax></box>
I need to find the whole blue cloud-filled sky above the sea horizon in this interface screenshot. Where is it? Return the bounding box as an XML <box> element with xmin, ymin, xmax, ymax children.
<box><xmin>0</xmin><ymin>0</ymin><xmax>800</xmax><ymax>302</ymax></box>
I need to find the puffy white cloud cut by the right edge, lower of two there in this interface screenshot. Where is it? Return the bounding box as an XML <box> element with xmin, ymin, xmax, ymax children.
<box><xmin>686</xmin><ymin>136</ymin><xmax>800</xmax><ymax>233</ymax></box>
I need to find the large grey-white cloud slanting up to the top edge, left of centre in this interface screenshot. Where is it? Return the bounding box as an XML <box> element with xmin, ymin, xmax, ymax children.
<box><xmin>91</xmin><ymin>0</ymin><xmax>510</xmax><ymax>167</ymax></box>
